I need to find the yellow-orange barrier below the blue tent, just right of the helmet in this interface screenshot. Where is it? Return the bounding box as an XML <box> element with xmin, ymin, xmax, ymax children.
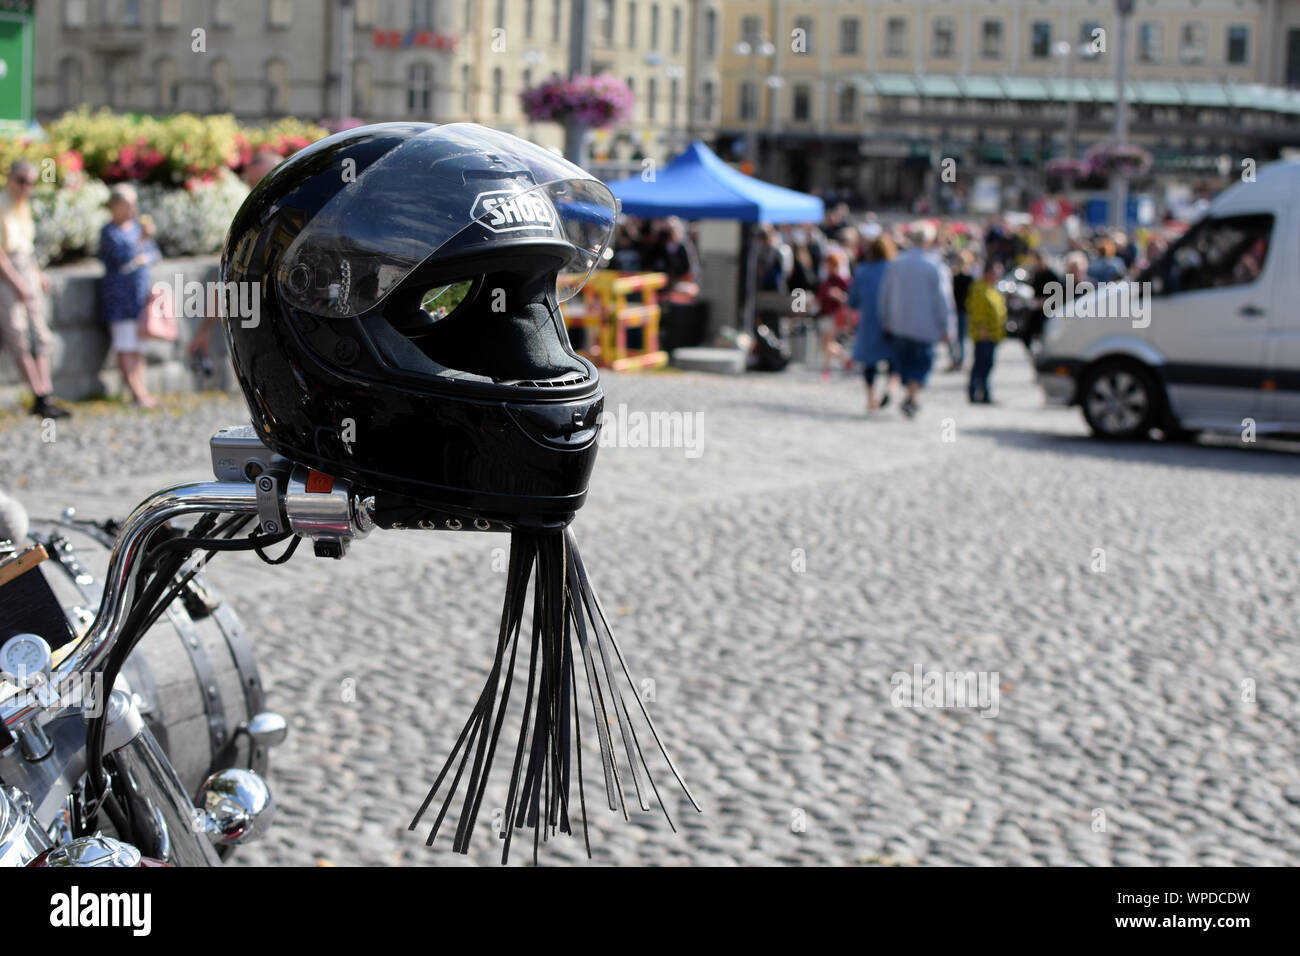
<box><xmin>564</xmin><ymin>269</ymin><xmax>668</xmax><ymax>372</ymax></box>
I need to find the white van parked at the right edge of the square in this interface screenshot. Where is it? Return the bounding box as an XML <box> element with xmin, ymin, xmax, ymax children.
<box><xmin>1035</xmin><ymin>160</ymin><xmax>1300</xmax><ymax>440</ymax></box>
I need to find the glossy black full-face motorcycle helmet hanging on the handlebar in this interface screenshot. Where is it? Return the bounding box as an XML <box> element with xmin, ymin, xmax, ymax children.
<box><xmin>221</xmin><ymin>124</ymin><xmax>618</xmax><ymax>528</ymax></box>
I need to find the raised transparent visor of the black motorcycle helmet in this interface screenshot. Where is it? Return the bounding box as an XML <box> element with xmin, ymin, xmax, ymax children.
<box><xmin>277</xmin><ymin>124</ymin><xmax>619</xmax><ymax>316</ymax></box>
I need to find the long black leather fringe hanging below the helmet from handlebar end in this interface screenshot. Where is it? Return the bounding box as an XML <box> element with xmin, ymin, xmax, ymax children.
<box><xmin>410</xmin><ymin>529</ymin><xmax>699</xmax><ymax>862</ymax></box>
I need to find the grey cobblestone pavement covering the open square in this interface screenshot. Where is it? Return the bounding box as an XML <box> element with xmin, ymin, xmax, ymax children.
<box><xmin>0</xmin><ymin>345</ymin><xmax>1300</xmax><ymax>865</ymax></box>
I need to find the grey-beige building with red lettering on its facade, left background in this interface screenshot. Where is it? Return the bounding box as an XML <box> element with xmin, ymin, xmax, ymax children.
<box><xmin>36</xmin><ymin>0</ymin><xmax>720</xmax><ymax>170</ymax></box>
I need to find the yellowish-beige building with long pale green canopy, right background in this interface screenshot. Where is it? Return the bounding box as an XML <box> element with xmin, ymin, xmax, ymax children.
<box><xmin>719</xmin><ymin>0</ymin><xmax>1300</xmax><ymax>203</ymax></box>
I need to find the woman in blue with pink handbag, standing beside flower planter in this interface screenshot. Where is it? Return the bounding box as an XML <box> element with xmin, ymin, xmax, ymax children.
<box><xmin>99</xmin><ymin>183</ymin><xmax>160</xmax><ymax>408</ymax></box>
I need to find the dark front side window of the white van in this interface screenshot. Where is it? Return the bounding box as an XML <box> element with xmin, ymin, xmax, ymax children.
<box><xmin>1143</xmin><ymin>213</ymin><xmax>1273</xmax><ymax>295</ymax></box>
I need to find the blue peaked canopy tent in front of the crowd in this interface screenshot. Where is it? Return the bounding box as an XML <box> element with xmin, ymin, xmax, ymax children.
<box><xmin>608</xmin><ymin>139</ymin><xmax>826</xmax><ymax>343</ymax></box>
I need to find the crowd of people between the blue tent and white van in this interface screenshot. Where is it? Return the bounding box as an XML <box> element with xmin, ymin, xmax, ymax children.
<box><xmin>755</xmin><ymin>206</ymin><xmax>1165</xmax><ymax>418</ymax></box>
